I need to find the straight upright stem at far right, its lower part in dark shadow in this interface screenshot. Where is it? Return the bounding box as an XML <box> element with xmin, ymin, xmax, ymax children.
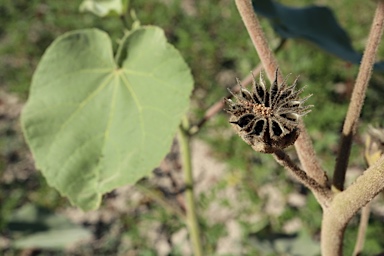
<box><xmin>333</xmin><ymin>0</ymin><xmax>384</xmax><ymax>191</ymax></box>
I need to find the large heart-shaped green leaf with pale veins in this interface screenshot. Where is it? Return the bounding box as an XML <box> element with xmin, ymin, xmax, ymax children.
<box><xmin>21</xmin><ymin>27</ymin><xmax>193</xmax><ymax>210</ymax></box>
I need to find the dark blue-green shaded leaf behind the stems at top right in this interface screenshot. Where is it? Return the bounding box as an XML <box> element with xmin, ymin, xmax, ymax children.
<box><xmin>252</xmin><ymin>0</ymin><xmax>384</xmax><ymax>71</ymax></box>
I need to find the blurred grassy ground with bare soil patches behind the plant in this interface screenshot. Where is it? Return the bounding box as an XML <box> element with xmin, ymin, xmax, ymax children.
<box><xmin>0</xmin><ymin>0</ymin><xmax>384</xmax><ymax>256</ymax></box>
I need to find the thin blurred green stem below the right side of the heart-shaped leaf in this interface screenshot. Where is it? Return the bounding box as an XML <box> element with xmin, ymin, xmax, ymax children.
<box><xmin>178</xmin><ymin>118</ymin><xmax>203</xmax><ymax>256</ymax></box>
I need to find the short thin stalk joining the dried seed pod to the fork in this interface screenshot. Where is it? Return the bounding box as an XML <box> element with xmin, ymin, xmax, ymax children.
<box><xmin>273</xmin><ymin>150</ymin><xmax>332</xmax><ymax>208</ymax></box>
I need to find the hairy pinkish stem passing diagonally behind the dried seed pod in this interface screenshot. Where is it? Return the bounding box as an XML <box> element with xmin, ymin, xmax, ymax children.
<box><xmin>235</xmin><ymin>0</ymin><xmax>328</xmax><ymax>186</ymax></box>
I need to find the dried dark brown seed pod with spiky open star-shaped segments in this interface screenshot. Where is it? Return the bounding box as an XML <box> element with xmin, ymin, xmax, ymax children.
<box><xmin>224</xmin><ymin>70</ymin><xmax>312</xmax><ymax>153</ymax></box>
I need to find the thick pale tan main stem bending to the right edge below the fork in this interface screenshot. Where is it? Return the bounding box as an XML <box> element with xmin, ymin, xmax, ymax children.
<box><xmin>321</xmin><ymin>156</ymin><xmax>384</xmax><ymax>256</ymax></box>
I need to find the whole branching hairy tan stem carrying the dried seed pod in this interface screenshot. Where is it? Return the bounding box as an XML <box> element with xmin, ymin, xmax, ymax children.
<box><xmin>235</xmin><ymin>0</ymin><xmax>384</xmax><ymax>256</ymax></box>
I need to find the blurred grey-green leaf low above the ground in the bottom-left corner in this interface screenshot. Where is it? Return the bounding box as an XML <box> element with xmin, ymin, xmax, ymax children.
<box><xmin>7</xmin><ymin>204</ymin><xmax>92</xmax><ymax>249</ymax></box>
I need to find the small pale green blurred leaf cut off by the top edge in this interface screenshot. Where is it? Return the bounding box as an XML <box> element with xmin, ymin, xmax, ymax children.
<box><xmin>80</xmin><ymin>0</ymin><xmax>129</xmax><ymax>17</ymax></box>
